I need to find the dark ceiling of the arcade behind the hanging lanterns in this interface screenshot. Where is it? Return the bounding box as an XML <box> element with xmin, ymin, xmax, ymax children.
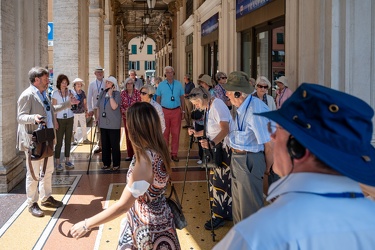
<box><xmin>114</xmin><ymin>0</ymin><xmax>171</xmax><ymax>38</ymax></box>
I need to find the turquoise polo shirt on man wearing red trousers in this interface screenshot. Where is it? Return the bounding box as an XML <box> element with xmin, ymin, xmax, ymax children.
<box><xmin>156</xmin><ymin>80</ymin><xmax>184</xmax><ymax>109</ymax></box>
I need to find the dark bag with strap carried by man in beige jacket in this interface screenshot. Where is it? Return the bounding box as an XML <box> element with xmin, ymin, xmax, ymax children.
<box><xmin>28</xmin><ymin>122</ymin><xmax>55</xmax><ymax>181</ymax></box>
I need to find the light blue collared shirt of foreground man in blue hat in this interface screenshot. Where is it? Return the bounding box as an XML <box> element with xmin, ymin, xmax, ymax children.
<box><xmin>213</xmin><ymin>174</ymin><xmax>375</xmax><ymax>250</ymax></box>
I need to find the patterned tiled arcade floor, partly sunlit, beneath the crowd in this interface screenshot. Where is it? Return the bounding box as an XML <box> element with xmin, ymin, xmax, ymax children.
<box><xmin>0</xmin><ymin>126</ymin><xmax>232</xmax><ymax>250</ymax></box>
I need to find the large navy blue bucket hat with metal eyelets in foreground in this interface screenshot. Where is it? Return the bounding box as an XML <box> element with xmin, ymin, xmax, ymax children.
<box><xmin>256</xmin><ymin>83</ymin><xmax>375</xmax><ymax>186</ymax></box>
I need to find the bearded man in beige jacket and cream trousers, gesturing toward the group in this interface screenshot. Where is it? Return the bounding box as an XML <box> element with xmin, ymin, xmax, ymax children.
<box><xmin>17</xmin><ymin>67</ymin><xmax>79</xmax><ymax>217</ymax></box>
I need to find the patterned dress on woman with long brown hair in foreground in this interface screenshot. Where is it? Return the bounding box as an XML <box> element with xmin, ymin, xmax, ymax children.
<box><xmin>118</xmin><ymin>151</ymin><xmax>180</xmax><ymax>250</ymax></box>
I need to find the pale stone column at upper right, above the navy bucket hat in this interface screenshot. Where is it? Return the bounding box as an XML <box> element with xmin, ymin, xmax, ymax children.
<box><xmin>285</xmin><ymin>0</ymin><xmax>375</xmax><ymax>144</ymax></box>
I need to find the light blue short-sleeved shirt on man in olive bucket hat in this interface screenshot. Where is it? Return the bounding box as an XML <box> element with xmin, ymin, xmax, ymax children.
<box><xmin>228</xmin><ymin>95</ymin><xmax>271</xmax><ymax>153</ymax></box>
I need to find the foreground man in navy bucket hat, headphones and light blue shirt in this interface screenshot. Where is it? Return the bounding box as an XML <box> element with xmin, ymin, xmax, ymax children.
<box><xmin>214</xmin><ymin>83</ymin><xmax>375</xmax><ymax>250</ymax></box>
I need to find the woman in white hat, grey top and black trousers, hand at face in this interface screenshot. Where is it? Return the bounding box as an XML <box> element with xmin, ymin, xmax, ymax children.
<box><xmin>96</xmin><ymin>76</ymin><xmax>121</xmax><ymax>170</ymax></box>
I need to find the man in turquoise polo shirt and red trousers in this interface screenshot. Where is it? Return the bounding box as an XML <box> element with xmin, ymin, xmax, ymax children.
<box><xmin>156</xmin><ymin>66</ymin><xmax>185</xmax><ymax>162</ymax></box>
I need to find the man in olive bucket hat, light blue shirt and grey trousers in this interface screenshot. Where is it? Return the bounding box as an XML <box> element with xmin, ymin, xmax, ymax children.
<box><xmin>223</xmin><ymin>71</ymin><xmax>273</xmax><ymax>223</ymax></box>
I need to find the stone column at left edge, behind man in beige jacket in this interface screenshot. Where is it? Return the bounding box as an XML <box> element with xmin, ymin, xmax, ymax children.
<box><xmin>0</xmin><ymin>0</ymin><xmax>48</xmax><ymax>193</ymax></box>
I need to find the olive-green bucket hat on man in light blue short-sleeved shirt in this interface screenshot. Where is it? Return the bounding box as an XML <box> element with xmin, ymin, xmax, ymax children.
<box><xmin>223</xmin><ymin>71</ymin><xmax>254</xmax><ymax>94</ymax></box>
